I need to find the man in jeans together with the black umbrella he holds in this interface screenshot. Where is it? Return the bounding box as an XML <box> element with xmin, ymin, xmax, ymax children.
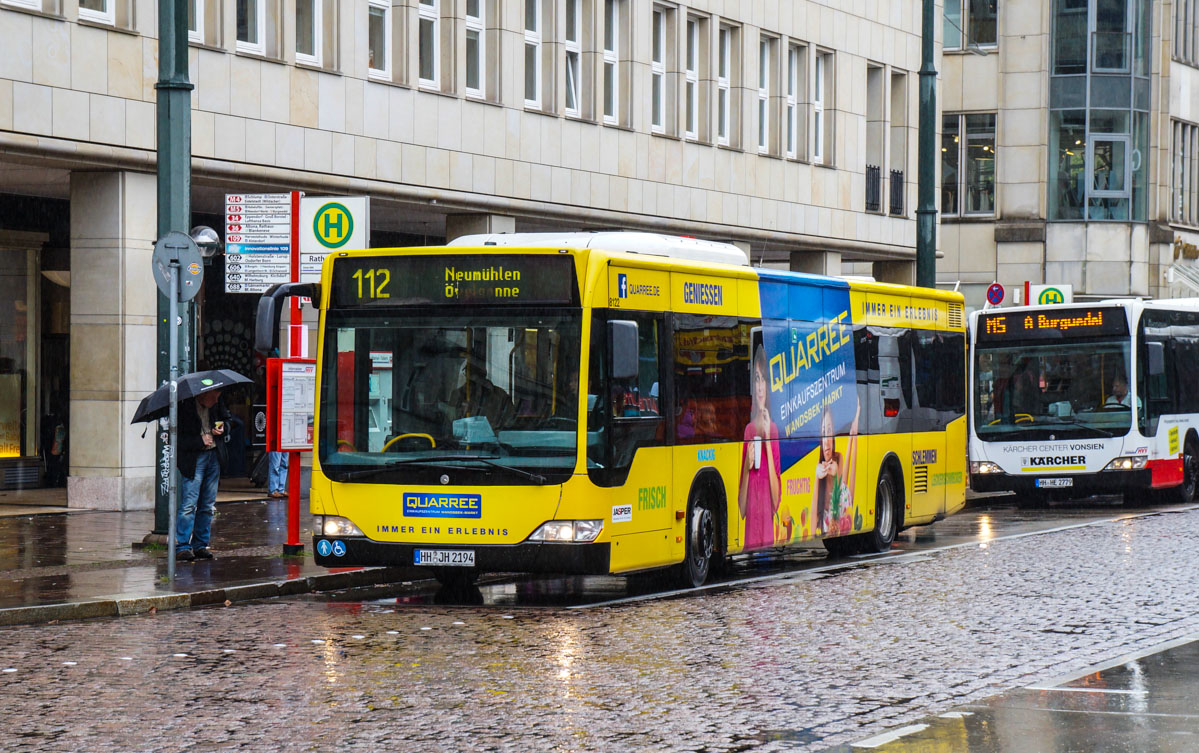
<box><xmin>133</xmin><ymin>369</ymin><xmax>251</xmax><ymax>562</ymax></box>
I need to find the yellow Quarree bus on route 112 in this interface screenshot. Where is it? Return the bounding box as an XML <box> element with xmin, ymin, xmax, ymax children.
<box><xmin>255</xmin><ymin>233</ymin><xmax>966</xmax><ymax>586</ymax></box>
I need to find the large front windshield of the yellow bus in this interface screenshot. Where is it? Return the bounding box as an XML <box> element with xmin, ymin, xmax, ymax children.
<box><xmin>319</xmin><ymin>308</ymin><xmax>582</xmax><ymax>484</ymax></box>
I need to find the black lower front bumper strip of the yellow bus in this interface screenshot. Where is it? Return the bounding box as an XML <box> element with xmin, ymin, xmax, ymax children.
<box><xmin>312</xmin><ymin>536</ymin><xmax>611</xmax><ymax>576</ymax></box>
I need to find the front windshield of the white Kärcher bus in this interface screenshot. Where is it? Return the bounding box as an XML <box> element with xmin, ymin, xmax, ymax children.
<box><xmin>974</xmin><ymin>338</ymin><xmax>1139</xmax><ymax>441</ymax></box>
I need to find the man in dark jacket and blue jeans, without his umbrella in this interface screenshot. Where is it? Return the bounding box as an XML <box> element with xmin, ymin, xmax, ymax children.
<box><xmin>175</xmin><ymin>390</ymin><xmax>229</xmax><ymax>562</ymax></box>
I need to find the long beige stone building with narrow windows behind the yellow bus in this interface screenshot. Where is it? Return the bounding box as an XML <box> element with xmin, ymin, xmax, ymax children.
<box><xmin>0</xmin><ymin>0</ymin><xmax>920</xmax><ymax>508</ymax></box>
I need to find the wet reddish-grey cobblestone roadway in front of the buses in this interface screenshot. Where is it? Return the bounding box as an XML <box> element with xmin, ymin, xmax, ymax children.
<box><xmin>0</xmin><ymin>511</ymin><xmax>1199</xmax><ymax>752</ymax></box>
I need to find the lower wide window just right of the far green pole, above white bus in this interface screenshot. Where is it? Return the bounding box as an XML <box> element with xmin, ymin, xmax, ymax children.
<box><xmin>941</xmin><ymin>113</ymin><xmax>995</xmax><ymax>217</ymax></box>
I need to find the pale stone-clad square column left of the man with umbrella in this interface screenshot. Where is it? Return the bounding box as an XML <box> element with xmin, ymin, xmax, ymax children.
<box><xmin>67</xmin><ymin>171</ymin><xmax>157</xmax><ymax>510</ymax></box>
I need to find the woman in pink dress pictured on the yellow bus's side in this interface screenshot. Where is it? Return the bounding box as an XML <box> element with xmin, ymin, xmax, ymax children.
<box><xmin>737</xmin><ymin>344</ymin><xmax>782</xmax><ymax>549</ymax></box>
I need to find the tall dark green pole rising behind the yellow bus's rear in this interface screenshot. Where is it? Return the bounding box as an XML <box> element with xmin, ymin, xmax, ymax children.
<box><xmin>916</xmin><ymin>0</ymin><xmax>936</xmax><ymax>288</ymax></box>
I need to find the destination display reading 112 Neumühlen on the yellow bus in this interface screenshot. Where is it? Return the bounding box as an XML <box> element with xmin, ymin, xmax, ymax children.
<box><xmin>332</xmin><ymin>254</ymin><xmax>578</xmax><ymax>307</ymax></box>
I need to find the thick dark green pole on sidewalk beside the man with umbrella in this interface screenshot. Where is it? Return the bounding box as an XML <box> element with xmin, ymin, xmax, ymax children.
<box><xmin>146</xmin><ymin>0</ymin><xmax>195</xmax><ymax>542</ymax></box>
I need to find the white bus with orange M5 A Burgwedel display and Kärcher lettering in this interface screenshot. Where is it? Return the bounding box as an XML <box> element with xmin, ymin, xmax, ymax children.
<box><xmin>969</xmin><ymin>299</ymin><xmax>1199</xmax><ymax>502</ymax></box>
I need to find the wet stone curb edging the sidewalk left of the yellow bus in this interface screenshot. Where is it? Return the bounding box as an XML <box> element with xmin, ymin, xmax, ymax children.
<box><xmin>0</xmin><ymin>567</ymin><xmax>412</xmax><ymax>627</ymax></box>
